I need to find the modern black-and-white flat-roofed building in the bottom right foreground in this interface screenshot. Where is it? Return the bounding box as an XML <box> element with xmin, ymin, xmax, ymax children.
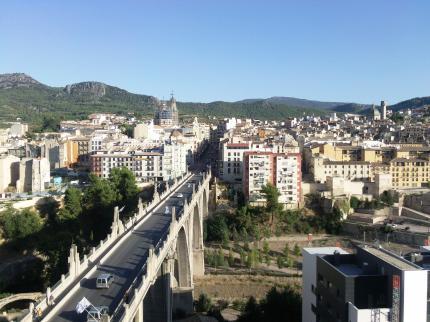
<box><xmin>302</xmin><ymin>246</ymin><xmax>427</xmax><ymax>322</ymax></box>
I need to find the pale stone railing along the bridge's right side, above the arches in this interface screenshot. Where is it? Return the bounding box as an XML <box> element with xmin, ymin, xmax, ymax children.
<box><xmin>112</xmin><ymin>170</ymin><xmax>210</xmax><ymax>322</ymax></box>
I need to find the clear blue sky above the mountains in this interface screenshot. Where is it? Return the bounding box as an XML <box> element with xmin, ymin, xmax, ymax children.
<box><xmin>0</xmin><ymin>0</ymin><xmax>430</xmax><ymax>103</ymax></box>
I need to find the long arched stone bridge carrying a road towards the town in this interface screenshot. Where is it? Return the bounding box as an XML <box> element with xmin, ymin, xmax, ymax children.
<box><xmin>21</xmin><ymin>171</ymin><xmax>210</xmax><ymax>322</ymax></box>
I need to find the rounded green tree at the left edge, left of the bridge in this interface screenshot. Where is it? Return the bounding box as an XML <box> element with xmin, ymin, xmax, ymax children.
<box><xmin>0</xmin><ymin>209</ymin><xmax>42</xmax><ymax>240</ymax></box>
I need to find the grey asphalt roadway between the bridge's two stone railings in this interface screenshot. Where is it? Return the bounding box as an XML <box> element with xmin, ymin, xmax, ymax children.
<box><xmin>49</xmin><ymin>175</ymin><xmax>202</xmax><ymax>322</ymax></box>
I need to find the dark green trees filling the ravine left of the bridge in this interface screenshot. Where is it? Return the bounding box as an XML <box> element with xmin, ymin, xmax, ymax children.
<box><xmin>0</xmin><ymin>168</ymin><xmax>143</xmax><ymax>292</ymax></box>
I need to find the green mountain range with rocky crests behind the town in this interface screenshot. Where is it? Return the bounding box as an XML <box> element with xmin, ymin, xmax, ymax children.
<box><xmin>0</xmin><ymin>73</ymin><xmax>430</xmax><ymax>128</ymax></box>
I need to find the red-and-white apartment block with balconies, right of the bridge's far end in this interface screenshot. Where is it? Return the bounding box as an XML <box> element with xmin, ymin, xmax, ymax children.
<box><xmin>243</xmin><ymin>151</ymin><xmax>302</xmax><ymax>208</ymax></box>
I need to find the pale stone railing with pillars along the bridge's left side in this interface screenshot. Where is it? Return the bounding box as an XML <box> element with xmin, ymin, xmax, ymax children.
<box><xmin>21</xmin><ymin>171</ymin><xmax>192</xmax><ymax>322</ymax></box>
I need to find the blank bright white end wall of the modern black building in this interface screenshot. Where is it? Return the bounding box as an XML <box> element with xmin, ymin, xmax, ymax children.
<box><xmin>401</xmin><ymin>270</ymin><xmax>427</xmax><ymax>322</ymax></box>
